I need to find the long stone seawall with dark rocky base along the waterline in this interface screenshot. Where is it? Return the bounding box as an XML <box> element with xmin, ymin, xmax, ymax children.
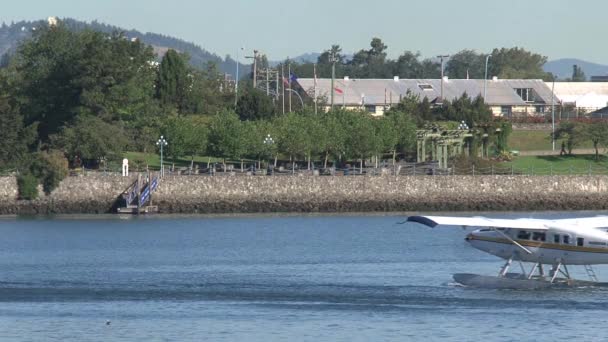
<box><xmin>0</xmin><ymin>176</ymin><xmax>608</xmax><ymax>214</ymax></box>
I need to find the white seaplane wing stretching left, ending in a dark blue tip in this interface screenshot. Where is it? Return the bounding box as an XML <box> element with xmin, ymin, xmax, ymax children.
<box><xmin>407</xmin><ymin>216</ymin><xmax>555</xmax><ymax>230</ymax></box>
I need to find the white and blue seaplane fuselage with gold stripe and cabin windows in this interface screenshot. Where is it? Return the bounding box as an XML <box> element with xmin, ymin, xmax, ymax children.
<box><xmin>466</xmin><ymin>227</ymin><xmax>608</xmax><ymax>265</ymax></box>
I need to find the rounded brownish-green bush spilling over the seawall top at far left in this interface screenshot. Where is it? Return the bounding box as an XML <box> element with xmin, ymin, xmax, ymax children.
<box><xmin>30</xmin><ymin>150</ymin><xmax>68</xmax><ymax>195</ymax></box>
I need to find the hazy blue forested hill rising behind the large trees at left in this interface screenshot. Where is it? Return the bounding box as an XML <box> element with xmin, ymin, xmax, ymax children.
<box><xmin>0</xmin><ymin>18</ymin><xmax>250</xmax><ymax>76</ymax></box>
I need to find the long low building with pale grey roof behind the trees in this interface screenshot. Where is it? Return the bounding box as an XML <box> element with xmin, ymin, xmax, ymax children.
<box><xmin>297</xmin><ymin>77</ymin><xmax>558</xmax><ymax>116</ymax></box>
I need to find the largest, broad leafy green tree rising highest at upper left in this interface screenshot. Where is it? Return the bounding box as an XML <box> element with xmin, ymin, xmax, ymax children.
<box><xmin>11</xmin><ymin>23</ymin><xmax>155</xmax><ymax>143</ymax></box>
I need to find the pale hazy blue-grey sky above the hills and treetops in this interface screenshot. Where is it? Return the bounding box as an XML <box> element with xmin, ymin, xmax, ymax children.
<box><xmin>0</xmin><ymin>0</ymin><xmax>608</xmax><ymax>64</ymax></box>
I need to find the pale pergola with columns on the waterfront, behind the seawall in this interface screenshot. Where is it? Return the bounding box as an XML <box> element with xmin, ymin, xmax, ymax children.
<box><xmin>416</xmin><ymin>126</ymin><xmax>500</xmax><ymax>168</ymax></box>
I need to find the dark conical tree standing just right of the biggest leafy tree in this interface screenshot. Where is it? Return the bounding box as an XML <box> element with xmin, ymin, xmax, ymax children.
<box><xmin>156</xmin><ymin>49</ymin><xmax>192</xmax><ymax>114</ymax></box>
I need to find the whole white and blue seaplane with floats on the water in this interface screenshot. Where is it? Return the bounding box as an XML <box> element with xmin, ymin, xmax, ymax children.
<box><xmin>405</xmin><ymin>216</ymin><xmax>608</xmax><ymax>289</ymax></box>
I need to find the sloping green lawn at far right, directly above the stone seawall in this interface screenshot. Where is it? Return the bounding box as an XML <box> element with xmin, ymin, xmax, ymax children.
<box><xmin>504</xmin><ymin>155</ymin><xmax>608</xmax><ymax>174</ymax></box>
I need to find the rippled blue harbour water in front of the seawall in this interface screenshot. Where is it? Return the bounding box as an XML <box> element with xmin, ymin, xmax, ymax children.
<box><xmin>0</xmin><ymin>213</ymin><xmax>608</xmax><ymax>341</ymax></box>
